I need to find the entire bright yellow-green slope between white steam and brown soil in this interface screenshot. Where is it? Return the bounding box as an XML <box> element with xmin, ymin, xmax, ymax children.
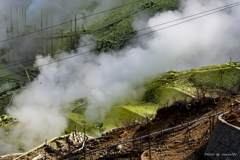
<box><xmin>64</xmin><ymin>64</ymin><xmax>240</xmax><ymax>136</ymax></box>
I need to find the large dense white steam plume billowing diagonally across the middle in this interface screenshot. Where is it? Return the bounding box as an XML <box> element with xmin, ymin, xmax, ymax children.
<box><xmin>2</xmin><ymin>0</ymin><xmax>240</xmax><ymax>152</ymax></box>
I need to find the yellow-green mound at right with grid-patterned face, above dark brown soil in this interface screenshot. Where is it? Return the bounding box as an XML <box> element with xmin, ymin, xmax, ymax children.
<box><xmin>144</xmin><ymin>63</ymin><xmax>240</xmax><ymax>106</ymax></box>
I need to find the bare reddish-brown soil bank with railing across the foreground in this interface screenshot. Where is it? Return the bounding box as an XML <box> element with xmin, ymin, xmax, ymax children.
<box><xmin>0</xmin><ymin>95</ymin><xmax>240</xmax><ymax>160</ymax></box>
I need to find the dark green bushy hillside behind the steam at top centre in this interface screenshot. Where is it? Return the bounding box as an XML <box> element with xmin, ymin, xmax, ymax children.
<box><xmin>55</xmin><ymin>0</ymin><xmax>180</xmax><ymax>53</ymax></box>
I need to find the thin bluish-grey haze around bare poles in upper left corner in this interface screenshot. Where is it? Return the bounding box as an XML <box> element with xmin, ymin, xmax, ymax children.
<box><xmin>0</xmin><ymin>0</ymin><xmax>125</xmax><ymax>68</ymax></box>
